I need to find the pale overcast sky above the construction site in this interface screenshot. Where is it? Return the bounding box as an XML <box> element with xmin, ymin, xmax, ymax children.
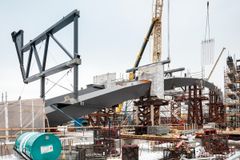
<box><xmin>0</xmin><ymin>0</ymin><xmax>240</xmax><ymax>99</ymax></box>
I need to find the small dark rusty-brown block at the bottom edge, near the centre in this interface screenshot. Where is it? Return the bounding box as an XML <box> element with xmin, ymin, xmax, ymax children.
<box><xmin>122</xmin><ymin>145</ymin><xmax>139</xmax><ymax>160</ymax></box>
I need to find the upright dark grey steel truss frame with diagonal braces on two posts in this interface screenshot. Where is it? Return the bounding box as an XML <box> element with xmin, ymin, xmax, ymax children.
<box><xmin>12</xmin><ymin>10</ymin><xmax>81</xmax><ymax>98</ymax></box>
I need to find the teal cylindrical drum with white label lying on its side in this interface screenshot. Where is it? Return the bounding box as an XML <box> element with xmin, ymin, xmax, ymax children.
<box><xmin>15</xmin><ymin>132</ymin><xmax>62</xmax><ymax>160</ymax></box>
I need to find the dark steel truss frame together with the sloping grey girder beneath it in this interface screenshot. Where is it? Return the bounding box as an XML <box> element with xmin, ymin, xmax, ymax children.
<box><xmin>12</xmin><ymin>10</ymin><xmax>151</xmax><ymax>126</ymax></box>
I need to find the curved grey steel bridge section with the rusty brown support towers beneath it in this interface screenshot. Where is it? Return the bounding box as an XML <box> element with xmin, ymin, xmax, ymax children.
<box><xmin>164</xmin><ymin>77</ymin><xmax>225</xmax><ymax>126</ymax></box>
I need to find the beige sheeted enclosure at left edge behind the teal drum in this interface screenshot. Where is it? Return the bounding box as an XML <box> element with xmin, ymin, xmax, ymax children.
<box><xmin>0</xmin><ymin>99</ymin><xmax>45</xmax><ymax>142</ymax></box>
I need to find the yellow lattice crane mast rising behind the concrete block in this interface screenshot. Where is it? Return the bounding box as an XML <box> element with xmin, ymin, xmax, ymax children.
<box><xmin>152</xmin><ymin>0</ymin><xmax>163</xmax><ymax>63</ymax></box>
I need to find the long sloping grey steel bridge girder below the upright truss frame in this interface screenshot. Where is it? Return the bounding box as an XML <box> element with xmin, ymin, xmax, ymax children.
<box><xmin>46</xmin><ymin>81</ymin><xmax>151</xmax><ymax>126</ymax></box>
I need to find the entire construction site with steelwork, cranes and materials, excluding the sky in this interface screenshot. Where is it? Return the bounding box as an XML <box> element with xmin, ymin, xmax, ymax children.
<box><xmin>0</xmin><ymin>0</ymin><xmax>240</xmax><ymax>160</ymax></box>
